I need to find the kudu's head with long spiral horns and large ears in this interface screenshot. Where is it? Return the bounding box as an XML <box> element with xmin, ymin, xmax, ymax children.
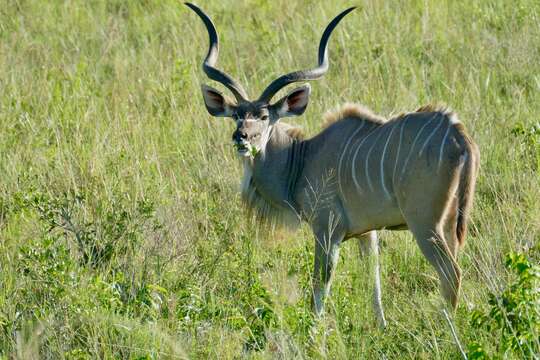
<box><xmin>186</xmin><ymin>3</ymin><xmax>355</xmax><ymax>156</ymax></box>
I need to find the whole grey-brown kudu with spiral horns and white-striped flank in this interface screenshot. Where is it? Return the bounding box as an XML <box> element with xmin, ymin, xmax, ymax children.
<box><xmin>186</xmin><ymin>3</ymin><xmax>479</xmax><ymax>326</ymax></box>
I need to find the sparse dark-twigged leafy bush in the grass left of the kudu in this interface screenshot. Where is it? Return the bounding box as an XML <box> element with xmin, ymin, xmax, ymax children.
<box><xmin>16</xmin><ymin>190</ymin><xmax>159</xmax><ymax>267</ymax></box>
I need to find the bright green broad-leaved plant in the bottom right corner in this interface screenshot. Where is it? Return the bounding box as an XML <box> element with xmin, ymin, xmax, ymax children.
<box><xmin>468</xmin><ymin>252</ymin><xmax>540</xmax><ymax>359</ymax></box>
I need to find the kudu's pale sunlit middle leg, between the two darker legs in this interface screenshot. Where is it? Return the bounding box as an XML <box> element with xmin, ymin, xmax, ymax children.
<box><xmin>358</xmin><ymin>231</ymin><xmax>386</xmax><ymax>328</ymax></box>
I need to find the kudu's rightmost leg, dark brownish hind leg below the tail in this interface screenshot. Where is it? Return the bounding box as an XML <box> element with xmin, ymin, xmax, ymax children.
<box><xmin>411</xmin><ymin>226</ymin><xmax>461</xmax><ymax>309</ymax></box>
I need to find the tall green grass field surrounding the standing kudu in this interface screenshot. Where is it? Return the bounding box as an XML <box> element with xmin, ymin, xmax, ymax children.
<box><xmin>0</xmin><ymin>0</ymin><xmax>540</xmax><ymax>359</ymax></box>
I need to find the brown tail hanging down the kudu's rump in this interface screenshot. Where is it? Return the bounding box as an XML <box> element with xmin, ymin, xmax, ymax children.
<box><xmin>456</xmin><ymin>124</ymin><xmax>480</xmax><ymax>247</ymax></box>
